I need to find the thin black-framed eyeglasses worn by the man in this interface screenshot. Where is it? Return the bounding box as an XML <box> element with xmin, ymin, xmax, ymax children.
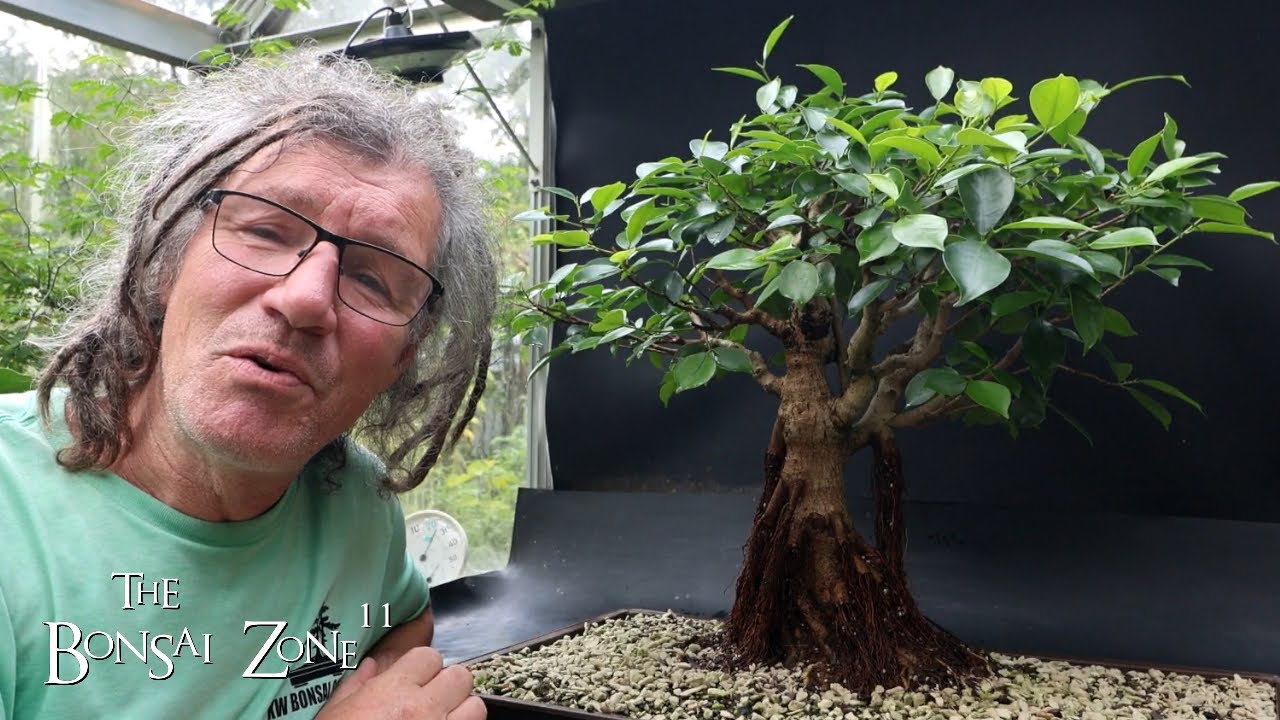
<box><xmin>201</xmin><ymin>190</ymin><xmax>444</xmax><ymax>325</ymax></box>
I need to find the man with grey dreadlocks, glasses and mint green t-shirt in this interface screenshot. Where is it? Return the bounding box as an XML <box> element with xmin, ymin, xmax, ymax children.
<box><xmin>0</xmin><ymin>50</ymin><xmax>495</xmax><ymax>720</ymax></box>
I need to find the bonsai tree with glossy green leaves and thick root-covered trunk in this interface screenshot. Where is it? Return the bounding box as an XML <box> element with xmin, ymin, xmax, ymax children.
<box><xmin>515</xmin><ymin>18</ymin><xmax>1280</xmax><ymax>692</ymax></box>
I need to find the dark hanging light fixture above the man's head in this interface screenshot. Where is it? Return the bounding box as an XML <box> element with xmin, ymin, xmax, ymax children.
<box><xmin>342</xmin><ymin>8</ymin><xmax>480</xmax><ymax>83</ymax></box>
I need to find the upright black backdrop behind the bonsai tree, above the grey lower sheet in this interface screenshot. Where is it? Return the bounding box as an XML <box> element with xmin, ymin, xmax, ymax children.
<box><xmin>547</xmin><ymin>0</ymin><xmax>1280</xmax><ymax>521</ymax></box>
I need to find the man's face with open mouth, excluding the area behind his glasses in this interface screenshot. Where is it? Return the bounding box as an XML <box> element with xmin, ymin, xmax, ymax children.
<box><xmin>148</xmin><ymin>145</ymin><xmax>440</xmax><ymax>471</ymax></box>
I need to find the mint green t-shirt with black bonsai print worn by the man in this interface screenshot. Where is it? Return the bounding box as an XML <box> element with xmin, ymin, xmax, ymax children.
<box><xmin>0</xmin><ymin>393</ymin><xmax>429</xmax><ymax>720</ymax></box>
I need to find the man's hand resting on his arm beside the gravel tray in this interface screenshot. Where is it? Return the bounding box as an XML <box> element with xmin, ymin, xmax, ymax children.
<box><xmin>316</xmin><ymin>647</ymin><xmax>488</xmax><ymax>720</ymax></box>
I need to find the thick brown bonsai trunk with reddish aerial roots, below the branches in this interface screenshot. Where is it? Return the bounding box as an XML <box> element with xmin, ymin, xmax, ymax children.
<box><xmin>726</xmin><ymin>353</ymin><xmax>987</xmax><ymax>693</ymax></box>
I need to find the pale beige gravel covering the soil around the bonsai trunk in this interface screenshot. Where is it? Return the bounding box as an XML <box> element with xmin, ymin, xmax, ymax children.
<box><xmin>471</xmin><ymin>614</ymin><xmax>1280</xmax><ymax>720</ymax></box>
